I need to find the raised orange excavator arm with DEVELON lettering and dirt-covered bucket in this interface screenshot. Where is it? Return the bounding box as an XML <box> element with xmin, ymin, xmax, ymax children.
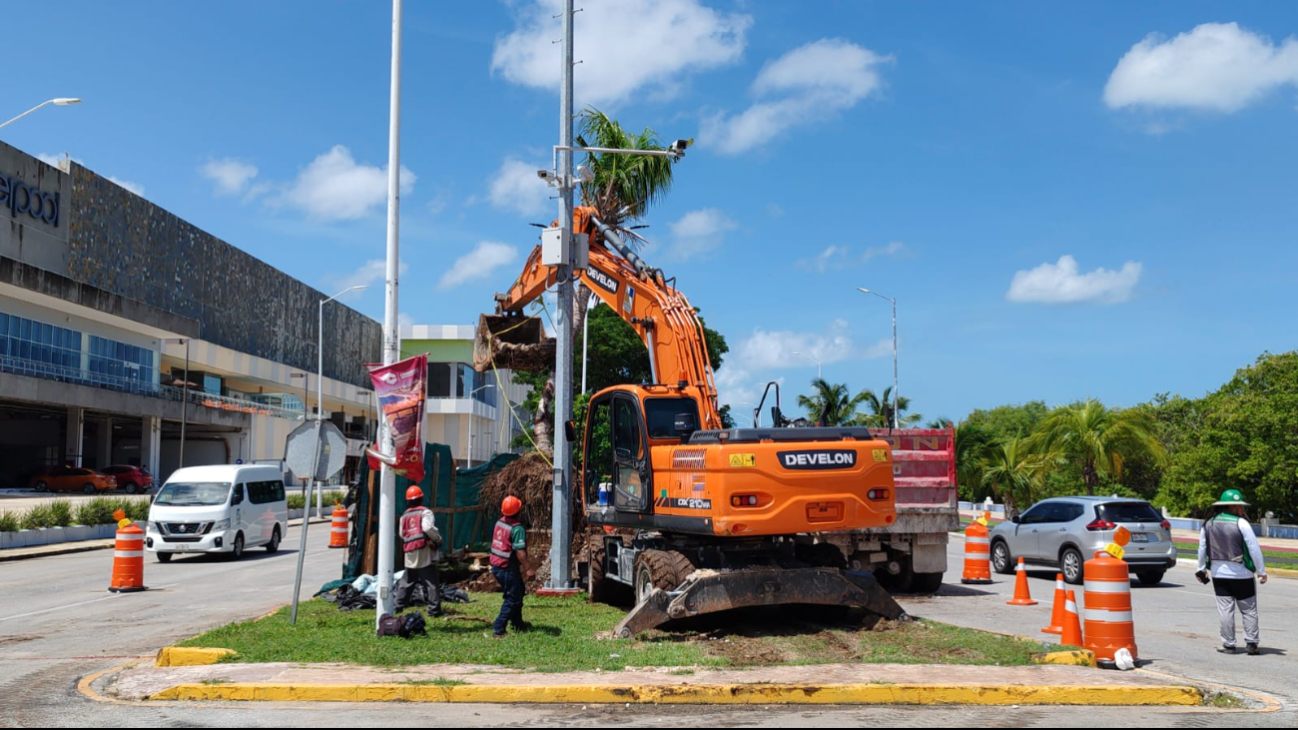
<box><xmin>475</xmin><ymin>207</ymin><xmax>722</xmax><ymax>430</ymax></box>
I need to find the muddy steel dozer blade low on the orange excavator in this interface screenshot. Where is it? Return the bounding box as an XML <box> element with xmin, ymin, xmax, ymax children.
<box><xmin>613</xmin><ymin>568</ymin><xmax>907</xmax><ymax>639</ymax></box>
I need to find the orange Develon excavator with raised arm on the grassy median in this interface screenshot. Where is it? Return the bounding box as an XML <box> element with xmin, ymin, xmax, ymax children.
<box><xmin>474</xmin><ymin>207</ymin><xmax>903</xmax><ymax>636</ymax></box>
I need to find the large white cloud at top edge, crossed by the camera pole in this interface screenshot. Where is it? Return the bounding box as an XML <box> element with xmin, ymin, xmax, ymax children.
<box><xmin>491</xmin><ymin>0</ymin><xmax>753</xmax><ymax>107</ymax></box>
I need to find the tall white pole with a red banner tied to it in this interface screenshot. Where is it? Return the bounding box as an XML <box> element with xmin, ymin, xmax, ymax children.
<box><xmin>374</xmin><ymin>0</ymin><xmax>401</xmax><ymax>629</ymax></box>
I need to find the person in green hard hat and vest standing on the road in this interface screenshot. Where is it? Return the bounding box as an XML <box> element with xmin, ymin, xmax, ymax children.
<box><xmin>1194</xmin><ymin>490</ymin><xmax>1267</xmax><ymax>656</ymax></box>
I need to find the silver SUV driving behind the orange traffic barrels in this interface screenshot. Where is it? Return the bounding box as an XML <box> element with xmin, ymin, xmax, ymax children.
<box><xmin>990</xmin><ymin>496</ymin><xmax>1176</xmax><ymax>586</ymax></box>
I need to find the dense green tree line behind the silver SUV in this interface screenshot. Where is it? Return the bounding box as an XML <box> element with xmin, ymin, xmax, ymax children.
<box><xmin>955</xmin><ymin>352</ymin><xmax>1298</xmax><ymax>523</ymax></box>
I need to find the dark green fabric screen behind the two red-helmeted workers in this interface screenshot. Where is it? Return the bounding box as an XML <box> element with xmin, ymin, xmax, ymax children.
<box><xmin>343</xmin><ymin>443</ymin><xmax>518</xmax><ymax>581</ymax></box>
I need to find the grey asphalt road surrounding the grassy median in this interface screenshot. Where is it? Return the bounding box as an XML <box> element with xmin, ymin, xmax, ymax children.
<box><xmin>0</xmin><ymin>525</ymin><xmax>1298</xmax><ymax>727</ymax></box>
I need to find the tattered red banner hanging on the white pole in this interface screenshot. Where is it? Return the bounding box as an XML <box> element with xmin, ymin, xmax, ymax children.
<box><xmin>365</xmin><ymin>355</ymin><xmax>428</xmax><ymax>482</ymax></box>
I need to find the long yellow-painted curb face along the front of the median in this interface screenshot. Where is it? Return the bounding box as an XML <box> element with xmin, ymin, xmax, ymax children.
<box><xmin>149</xmin><ymin>683</ymin><xmax>1203</xmax><ymax>705</ymax></box>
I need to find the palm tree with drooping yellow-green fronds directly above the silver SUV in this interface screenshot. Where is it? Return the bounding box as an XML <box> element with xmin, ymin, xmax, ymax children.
<box><xmin>1033</xmin><ymin>399</ymin><xmax>1167</xmax><ymax>496</ymax></box>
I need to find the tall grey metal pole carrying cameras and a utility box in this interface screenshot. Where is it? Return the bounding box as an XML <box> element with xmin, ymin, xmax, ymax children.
<box><xmin>545</xmin><ymin>0</ymin><xmax>574</xmax><ymax>591</ymax></box>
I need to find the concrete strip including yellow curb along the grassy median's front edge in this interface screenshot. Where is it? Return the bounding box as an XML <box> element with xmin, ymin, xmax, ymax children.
<box><xmin>104</xmin><ymin>657</ymin><xmax>1203</xmax><ymax>705</ymax></box>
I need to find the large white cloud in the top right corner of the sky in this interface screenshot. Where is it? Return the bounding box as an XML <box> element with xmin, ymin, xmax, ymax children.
<box><xmin>1105</xmin><ymin>23</ymin><xmax>1298</xmax><ymax>112</ymax></box>
